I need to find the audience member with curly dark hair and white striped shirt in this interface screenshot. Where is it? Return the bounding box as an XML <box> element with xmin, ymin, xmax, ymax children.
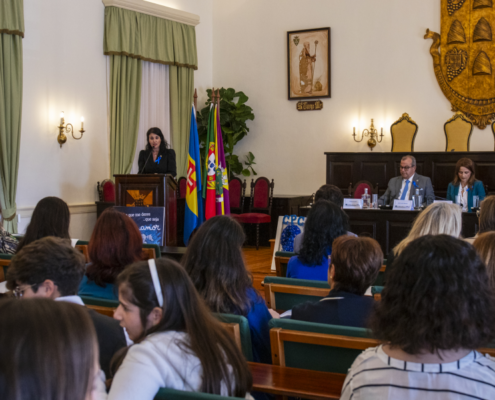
<box><xmin>341</xmin><ymin>235</ymin><xmax>495</xmax><ymax>400</ymax></box>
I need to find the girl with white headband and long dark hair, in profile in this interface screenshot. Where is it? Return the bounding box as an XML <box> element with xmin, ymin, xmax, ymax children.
<box><xmin>108</xmin><ymin>258</ymin><xmax>252</xmax><ymax>400</ymax></box>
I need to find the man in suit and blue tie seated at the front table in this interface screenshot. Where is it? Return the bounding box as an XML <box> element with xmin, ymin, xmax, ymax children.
<box><xmin>380</xmin><ymin>155</ymin><xmax>435</xmax><ymax>205</ymax></box>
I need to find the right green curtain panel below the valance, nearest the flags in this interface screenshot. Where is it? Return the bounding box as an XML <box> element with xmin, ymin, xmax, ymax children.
<box><xmin>169</xmin><ymin>66</ymin><xmax>194</xmax><ymax>176</ymax></box>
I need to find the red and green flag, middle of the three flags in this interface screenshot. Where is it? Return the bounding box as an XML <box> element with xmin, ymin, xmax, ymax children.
<box><xmin>203</xmin><ymin>104</ymin><xmax>218</xmax><ymax>219</ymax></box>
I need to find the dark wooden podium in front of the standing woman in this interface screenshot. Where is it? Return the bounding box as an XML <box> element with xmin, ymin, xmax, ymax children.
<box><xmin>114</xmin><ymin>174</ymin><xmax>177</xmax><ymax>246</ymax></box>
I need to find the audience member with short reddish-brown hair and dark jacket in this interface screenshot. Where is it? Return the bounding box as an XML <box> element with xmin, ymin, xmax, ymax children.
<box><xmin>291</xmin><ymin>236</ymin><xmax>383</xmax><ymax>328</ymax></box>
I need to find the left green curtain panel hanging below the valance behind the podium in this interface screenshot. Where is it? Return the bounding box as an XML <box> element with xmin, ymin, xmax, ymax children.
<box><xmin>110</xmin><ymin>56</ymin><xmax>141</xmax><ymax>179</ymax></box>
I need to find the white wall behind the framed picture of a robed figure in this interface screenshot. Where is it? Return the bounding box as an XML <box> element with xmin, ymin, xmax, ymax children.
<box><xmin>213</xmin><ymin>0</ymin><xmax>493</xmax><ymax>194</ymax></box>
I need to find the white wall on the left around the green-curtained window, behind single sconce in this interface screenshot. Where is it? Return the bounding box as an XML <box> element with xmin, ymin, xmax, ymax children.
<box><xmin>17</xmin><ymin>0</ymin><xmax>213</xmax><ymax>240</ymax></box>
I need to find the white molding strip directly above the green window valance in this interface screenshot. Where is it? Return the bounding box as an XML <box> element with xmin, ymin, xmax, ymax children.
<box><xmin>102</xmin><ymin>0</ymin><xmax>199</xmax><ymax>26</ymax></box>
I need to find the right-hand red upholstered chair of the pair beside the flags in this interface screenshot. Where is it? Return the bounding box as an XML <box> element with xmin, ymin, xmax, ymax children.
<box><xmin>233</xmin><ymin>177</ymin><xmax>275</xmax><ymax>250</ymax></box>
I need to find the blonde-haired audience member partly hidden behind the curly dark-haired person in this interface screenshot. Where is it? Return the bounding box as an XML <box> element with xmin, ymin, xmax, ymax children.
<box><xmin>385</xmin><ymin>203</ymin><xmax>462</xmax><ymax>281</ymax></box>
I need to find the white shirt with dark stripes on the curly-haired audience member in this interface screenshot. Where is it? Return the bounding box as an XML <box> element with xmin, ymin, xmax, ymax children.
<box><xmin>341</xmin><ymin>346</ymin><xmax>495</xmax><ymax>400</ymax></box>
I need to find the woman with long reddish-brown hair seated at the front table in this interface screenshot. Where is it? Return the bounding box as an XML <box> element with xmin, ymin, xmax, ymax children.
<box><xmin>447</xmin><ymin>158</ymin><xmax>486</xmax><ymax>212</ymax></box>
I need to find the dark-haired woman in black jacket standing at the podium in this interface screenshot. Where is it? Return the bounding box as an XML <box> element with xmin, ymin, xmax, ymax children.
<box><xmin>138</xmin><ymin>128</ymin><xmax>177</xmax><ymax>177</ymax></box>
